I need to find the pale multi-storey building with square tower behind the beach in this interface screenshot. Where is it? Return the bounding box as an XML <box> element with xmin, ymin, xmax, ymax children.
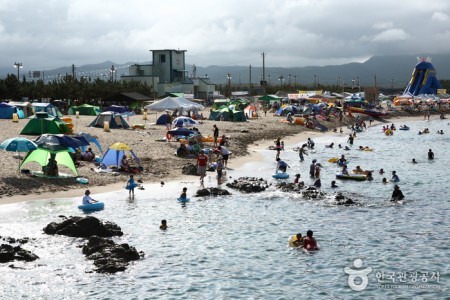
<box><xmin>120</xmin><ymin>49</ymin><xmax>215</xmax><ymax>99</ymax></box>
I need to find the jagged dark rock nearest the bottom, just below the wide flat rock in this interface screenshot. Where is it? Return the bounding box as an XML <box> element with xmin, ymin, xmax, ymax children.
<box><xmin>83</xmin><ymin>236</ymin><xmax>144</xmax><ymax>273</ymax></box>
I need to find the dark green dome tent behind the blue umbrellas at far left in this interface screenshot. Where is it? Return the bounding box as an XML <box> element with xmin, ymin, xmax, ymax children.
<box><xmin>20</xmin><ymin>113</ymin><xmax>70</xmax><ymax>135</ymax></box>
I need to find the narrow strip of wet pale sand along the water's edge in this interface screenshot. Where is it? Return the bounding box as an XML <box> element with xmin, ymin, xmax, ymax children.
<box><xmin>0</xmin><ymin>115</ymin><xmax>434</xmax><ymax>205</ymax></box>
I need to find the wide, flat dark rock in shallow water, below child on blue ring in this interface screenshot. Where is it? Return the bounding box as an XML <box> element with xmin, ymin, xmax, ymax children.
<box><xmin>43</xmin><ymin>216</ymin><xmax>123</xmax><ymax>238</ymax></box>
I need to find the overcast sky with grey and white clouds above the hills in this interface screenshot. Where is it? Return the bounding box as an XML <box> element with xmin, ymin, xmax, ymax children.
<box><xmin>0</xmin><ymin>0</ymin><xmax>450</xmax><ymax>70</ymax></box>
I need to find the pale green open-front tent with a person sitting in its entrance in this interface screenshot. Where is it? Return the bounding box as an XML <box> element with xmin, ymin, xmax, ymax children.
<box><xmin>20</xmin><ymin>147</ymin><xmax>78</xmax><ymax>176</ymax></box>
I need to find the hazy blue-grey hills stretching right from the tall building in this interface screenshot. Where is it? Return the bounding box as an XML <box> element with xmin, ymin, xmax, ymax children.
<box><xmin>192</xmin><ymin>54</ymin><xmax>450</xmax><ymax>87</ymax></box>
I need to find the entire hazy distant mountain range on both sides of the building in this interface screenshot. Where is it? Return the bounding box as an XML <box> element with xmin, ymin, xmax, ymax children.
<box><xmin>0</xmin><ymin>54</ymin><xmax>450</xmax><ymax>88</ymax></box>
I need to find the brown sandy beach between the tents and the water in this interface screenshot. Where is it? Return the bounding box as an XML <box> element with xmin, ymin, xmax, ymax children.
<box><xmin>0</xmin><ymin>107</ymin><xmax>438</xmax><ymax>204</ymax></box>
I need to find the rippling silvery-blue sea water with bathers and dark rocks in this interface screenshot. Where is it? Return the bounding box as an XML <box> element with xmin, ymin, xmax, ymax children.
<box><xmin>0</xmin><ymin>120</ymin><xmax>450</xmax><ymax>299</ymax></box>
